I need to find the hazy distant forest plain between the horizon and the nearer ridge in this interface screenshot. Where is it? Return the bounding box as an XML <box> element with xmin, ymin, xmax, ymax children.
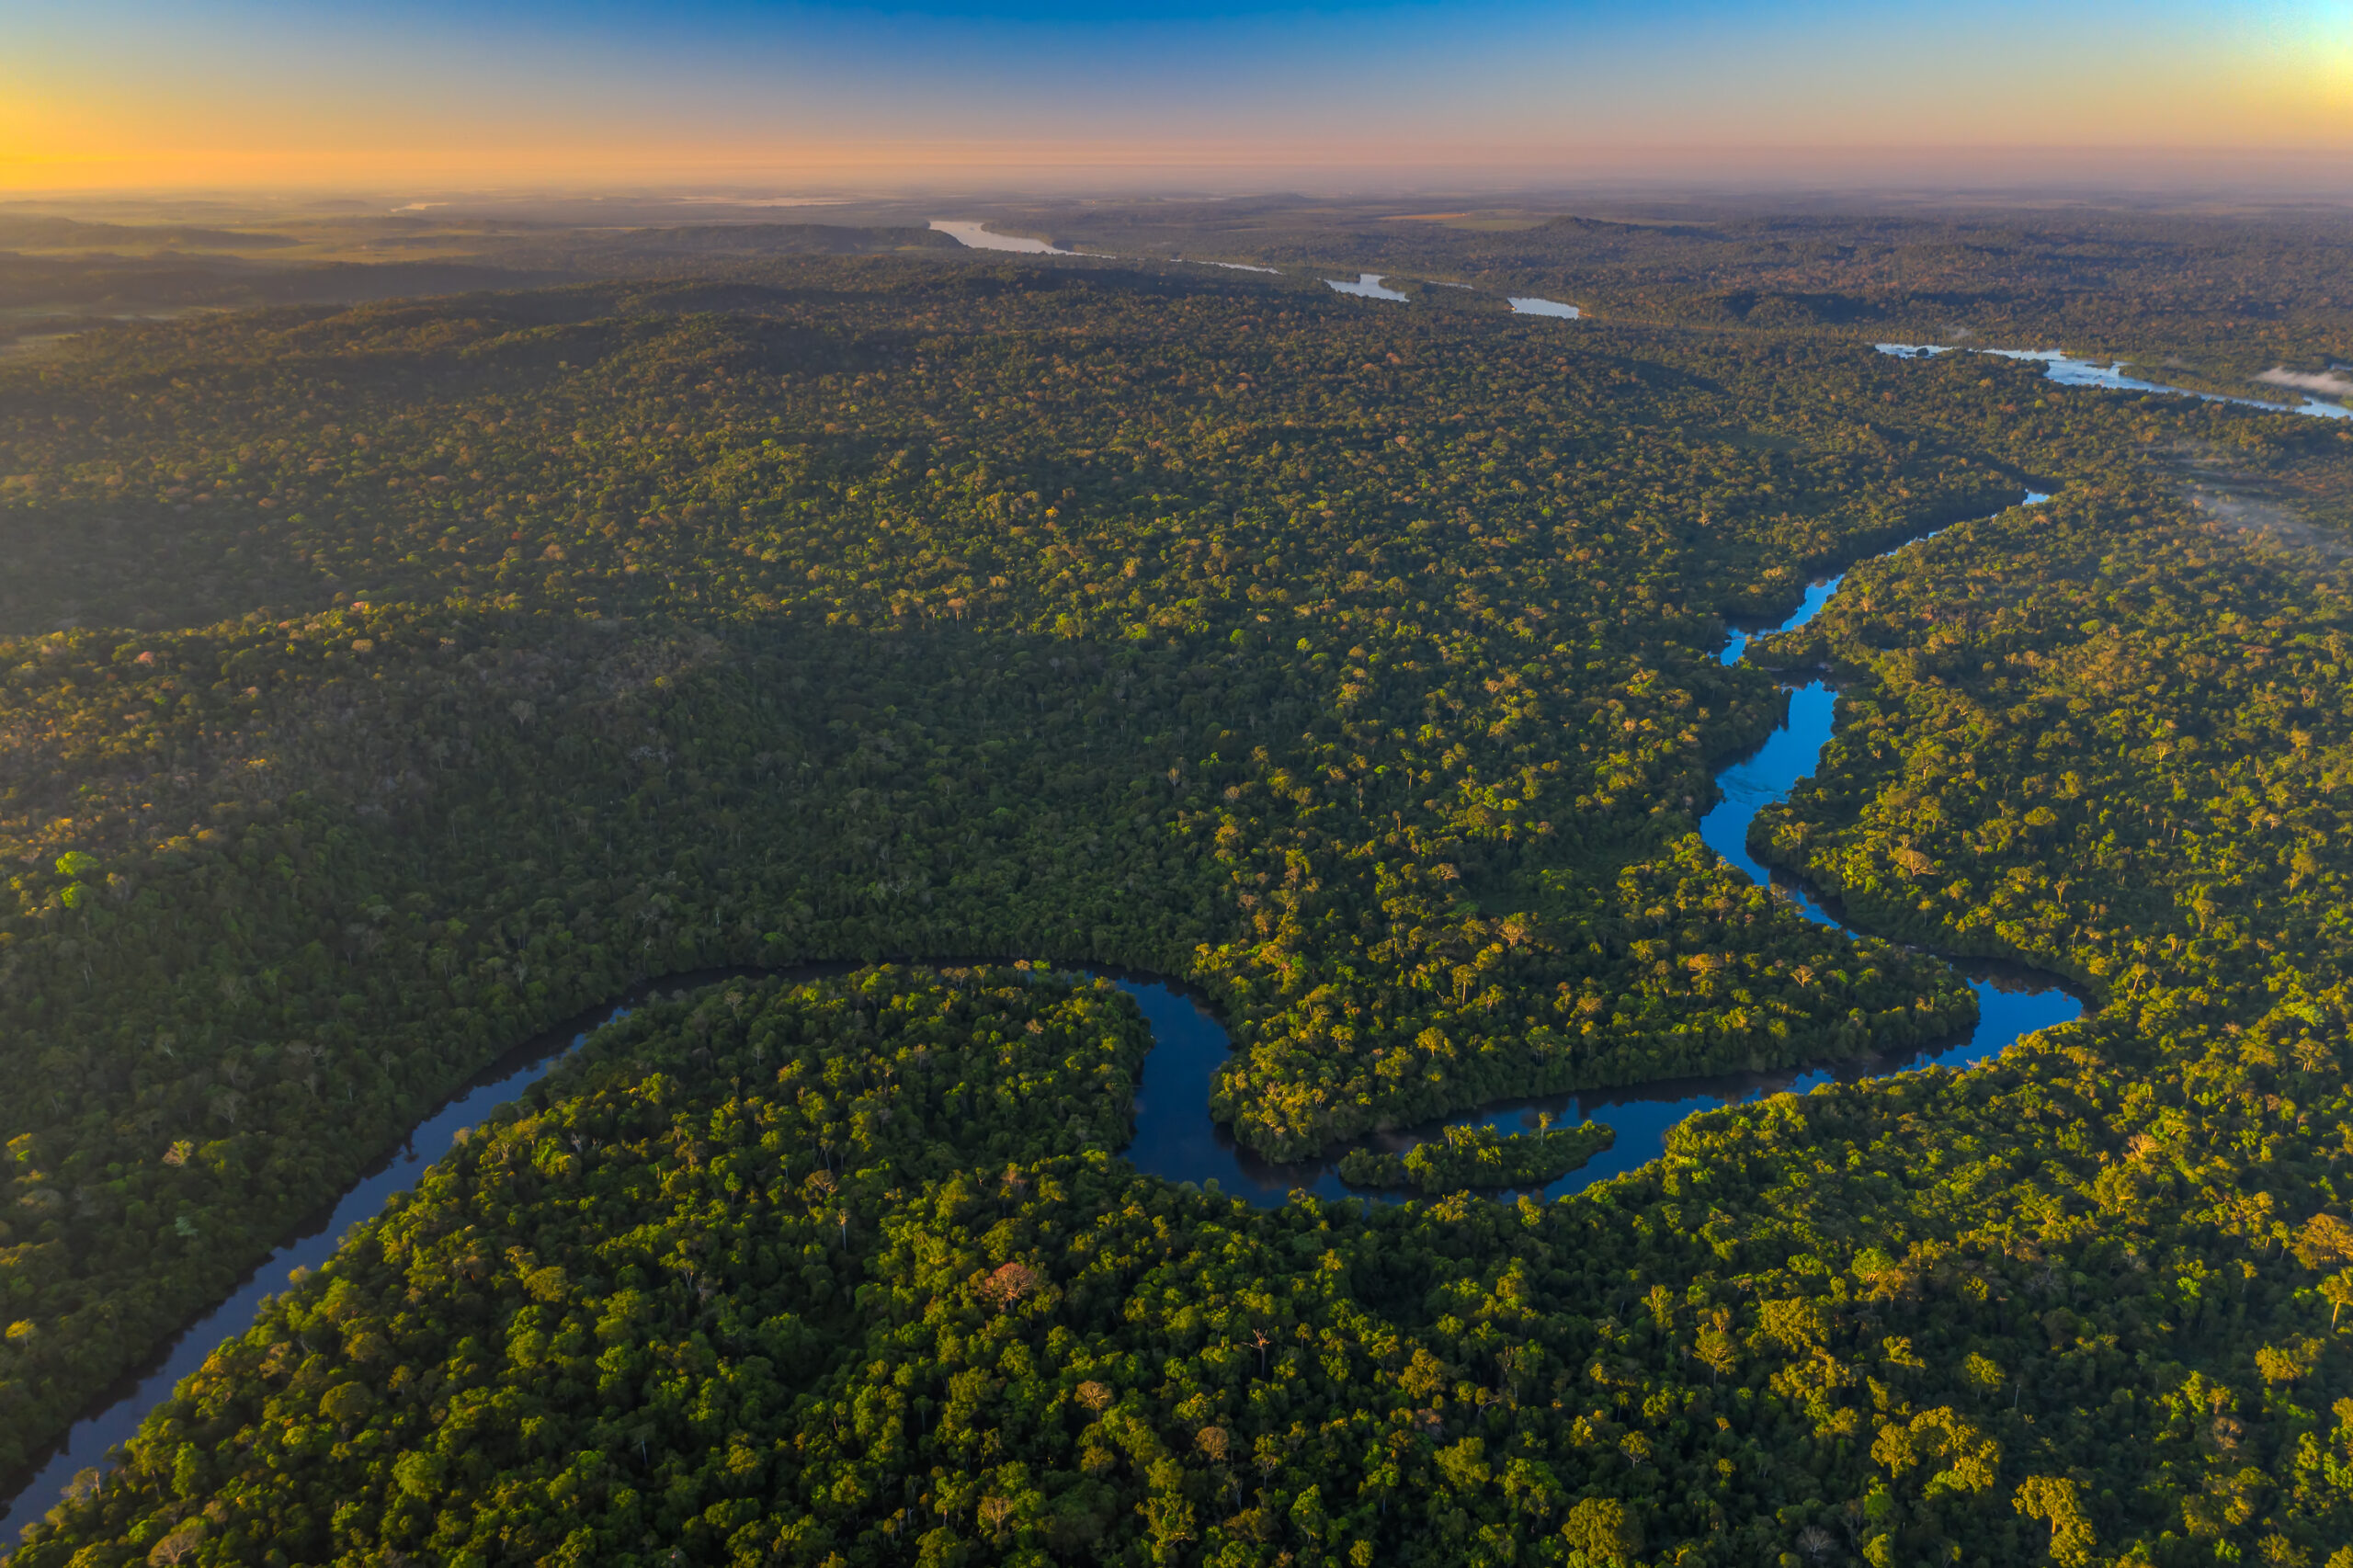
<box><xmin>22</xmin><ymin>193</ymin><xmax>2353</xmax><ymax>403</ymax></box>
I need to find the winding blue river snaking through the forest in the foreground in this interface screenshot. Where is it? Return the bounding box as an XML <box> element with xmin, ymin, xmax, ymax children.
<box><xmin>5</xmin><ymin>496</ymin><xmax>2083</xmax><ymax>1547</ymax></box>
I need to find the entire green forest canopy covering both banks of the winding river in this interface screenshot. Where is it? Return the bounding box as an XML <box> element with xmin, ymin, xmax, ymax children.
<box><xmin>0</xmin><ymin>210</ymin><xmax>2353</xmax><ymax>1568</ymax></box>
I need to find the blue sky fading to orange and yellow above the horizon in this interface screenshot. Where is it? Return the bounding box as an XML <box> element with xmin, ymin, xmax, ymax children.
<box><xmin>0</xmin><ymin>0</ymin><xmax>2353</xmax><ymax>196</ymax></box>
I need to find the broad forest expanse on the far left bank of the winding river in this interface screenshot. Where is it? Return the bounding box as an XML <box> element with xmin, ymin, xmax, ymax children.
<box><xmin>0</xmin><ymin>266</ymin><xmax>2014</xmax><ymax>1458</ymax></box>
